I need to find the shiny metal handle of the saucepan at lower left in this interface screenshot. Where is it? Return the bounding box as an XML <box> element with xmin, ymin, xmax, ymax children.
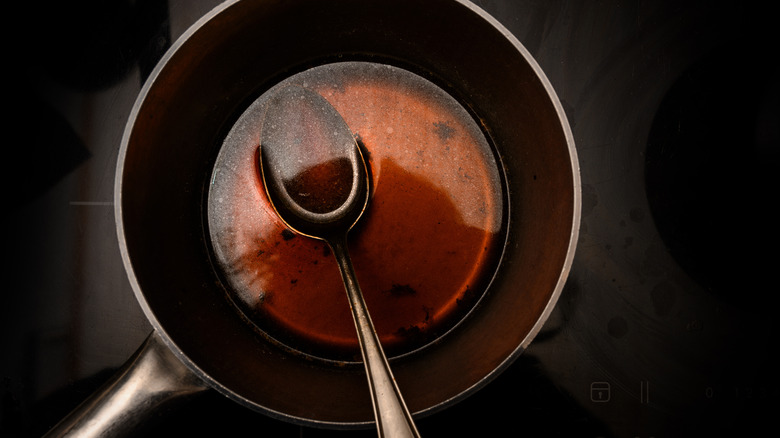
<box><xmin>45</xmin><ymin>330</ymin><xmax>207</xmax><ymax>437</ymax></box>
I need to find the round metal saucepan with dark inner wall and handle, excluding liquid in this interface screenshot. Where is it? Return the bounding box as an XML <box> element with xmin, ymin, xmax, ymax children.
<box><xmin>42</xmin><ymin>0</ymin><xmax>580</xmax><ymax>435</ymax></box>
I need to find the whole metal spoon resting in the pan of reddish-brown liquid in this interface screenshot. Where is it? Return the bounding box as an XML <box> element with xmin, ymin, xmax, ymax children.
<box><xmin>258</xmin><ymin>86</ymin><xmax>419</xmax><ymax>437</ymax></box>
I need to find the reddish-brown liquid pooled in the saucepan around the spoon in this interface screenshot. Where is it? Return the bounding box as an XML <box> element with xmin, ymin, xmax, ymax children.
<box><xmin>208</xmin><ymin>62</ymin><xmax>504</xmax><ymax>360</ymax></box>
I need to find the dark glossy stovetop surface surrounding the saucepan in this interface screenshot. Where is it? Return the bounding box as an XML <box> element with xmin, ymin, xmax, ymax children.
<box><xmin>0</xmin><ymin>0</ymin><xmax>780</xmax><ymax>438</ymax></box>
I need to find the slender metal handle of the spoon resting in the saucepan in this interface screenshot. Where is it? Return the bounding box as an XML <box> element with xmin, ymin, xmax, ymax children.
<box><xmin>329</xmin><ymin>236</ymin><xmax>420</xmax><ymax>437</ymax></box>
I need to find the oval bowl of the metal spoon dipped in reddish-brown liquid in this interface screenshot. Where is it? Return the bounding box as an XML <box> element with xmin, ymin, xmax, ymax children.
<box><xmin>259</xmin><ymin>86</ymin><xmax>369</xmax><ymax>236</ymax></box>
